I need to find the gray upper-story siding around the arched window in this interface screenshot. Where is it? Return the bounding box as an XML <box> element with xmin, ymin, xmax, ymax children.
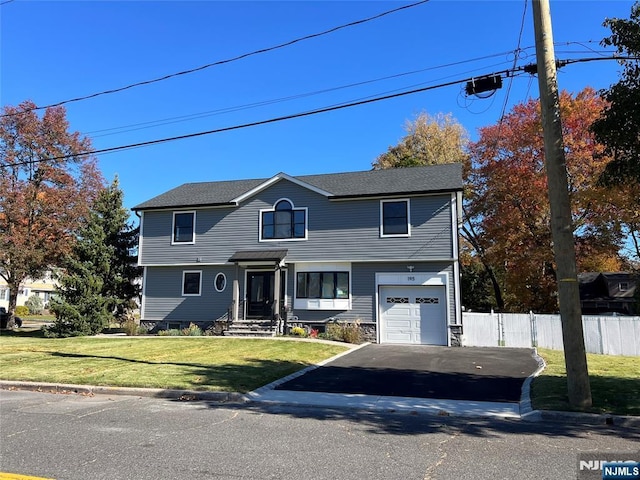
<box><xmin>140</xmin><ymin>180</ymin><xmax>453</xmax><ymax>265</ymax></box>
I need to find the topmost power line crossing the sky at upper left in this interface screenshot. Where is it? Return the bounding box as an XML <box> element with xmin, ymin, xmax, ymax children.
<box><xmin>1</xmin><ymin>0</ymin><xmax>430</xmax><ymax>117</ymax></box>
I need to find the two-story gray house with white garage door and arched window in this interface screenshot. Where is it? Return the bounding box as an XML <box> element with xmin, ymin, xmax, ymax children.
<box><xmin>133</xmin><ymin>164</ymin><xmax>462</xmax><ymax>345</ymax></box>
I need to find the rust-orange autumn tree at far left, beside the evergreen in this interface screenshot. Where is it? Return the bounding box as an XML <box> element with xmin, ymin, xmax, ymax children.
<box><xmin>0</xmin><ymin>101</ymin><xmax>102</xmax><ymax>323</ymax></box>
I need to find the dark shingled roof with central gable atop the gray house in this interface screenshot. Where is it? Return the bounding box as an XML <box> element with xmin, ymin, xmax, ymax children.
<box><xmin>133</xmin><ymin>163</ymin><xmax>462</xmax><ymax>210</ymax></box>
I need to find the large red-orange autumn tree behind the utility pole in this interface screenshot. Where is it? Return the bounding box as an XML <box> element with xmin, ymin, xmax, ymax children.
<box><xmin>466</xmin><ymin>88</ymin><xmax>623</xmax><ymax>312</ymax></box>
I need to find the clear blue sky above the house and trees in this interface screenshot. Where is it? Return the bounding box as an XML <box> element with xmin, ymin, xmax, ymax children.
<box><xmin>0</xmin><ymin>0</ymin><xmax>633</xmax><ymax>212</ymax></box>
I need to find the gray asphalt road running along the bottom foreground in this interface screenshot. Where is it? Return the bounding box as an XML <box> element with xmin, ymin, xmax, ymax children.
<box><xmin>0</xmin><ymin>391</ymin><xmax>640</xmax><ymax>480</ymax></box>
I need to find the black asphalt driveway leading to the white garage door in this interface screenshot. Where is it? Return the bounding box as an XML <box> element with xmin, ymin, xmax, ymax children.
<box><xmin>276</xmin><ymin>344</ymin><xmax>538</xmax><ymax>403</ymax></box>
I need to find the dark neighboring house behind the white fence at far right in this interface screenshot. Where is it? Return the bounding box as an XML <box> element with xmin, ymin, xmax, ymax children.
<box><xmin>578</xmin><ymin>272</ymin><xmax>640</xmax><ymax>315</ymax></box>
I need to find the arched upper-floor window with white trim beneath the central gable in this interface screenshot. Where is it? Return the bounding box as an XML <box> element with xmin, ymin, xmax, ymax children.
<box><xmin>260</xmin><ymin>199</ymin><xmax>307</xmax><ymax>240</ymax></box>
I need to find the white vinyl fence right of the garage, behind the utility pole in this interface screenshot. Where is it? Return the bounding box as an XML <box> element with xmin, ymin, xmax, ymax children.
<box><xmin>462</xmin><ymin>312</ymin><xmax>640</xmax><ymax>356</ymax></box>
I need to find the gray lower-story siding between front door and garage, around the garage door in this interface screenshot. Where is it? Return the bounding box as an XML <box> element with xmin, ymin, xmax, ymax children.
<box><xmin>288</xmin><ymin>262</ymin><xmax>456</xmax><ymax>323</ymax></box>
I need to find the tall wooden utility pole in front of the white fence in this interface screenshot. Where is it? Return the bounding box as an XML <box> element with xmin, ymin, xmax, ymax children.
<box><xmin>533</xmin><ymin>0</ymin><xmax>591</xmax><ymax>409</ymax></box>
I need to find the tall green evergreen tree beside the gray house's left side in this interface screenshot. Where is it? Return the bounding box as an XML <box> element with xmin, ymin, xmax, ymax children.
<box><xmin>46</xmin><ymin>178</ymin><xmax>140</xmax><ymax>336</ymax></box>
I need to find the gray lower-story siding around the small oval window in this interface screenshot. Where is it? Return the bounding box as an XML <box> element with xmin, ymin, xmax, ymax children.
<box><xmin>142</xmin><ymin>265</ymin><xmax>235</xmax><ymax>322</ymax></box>
